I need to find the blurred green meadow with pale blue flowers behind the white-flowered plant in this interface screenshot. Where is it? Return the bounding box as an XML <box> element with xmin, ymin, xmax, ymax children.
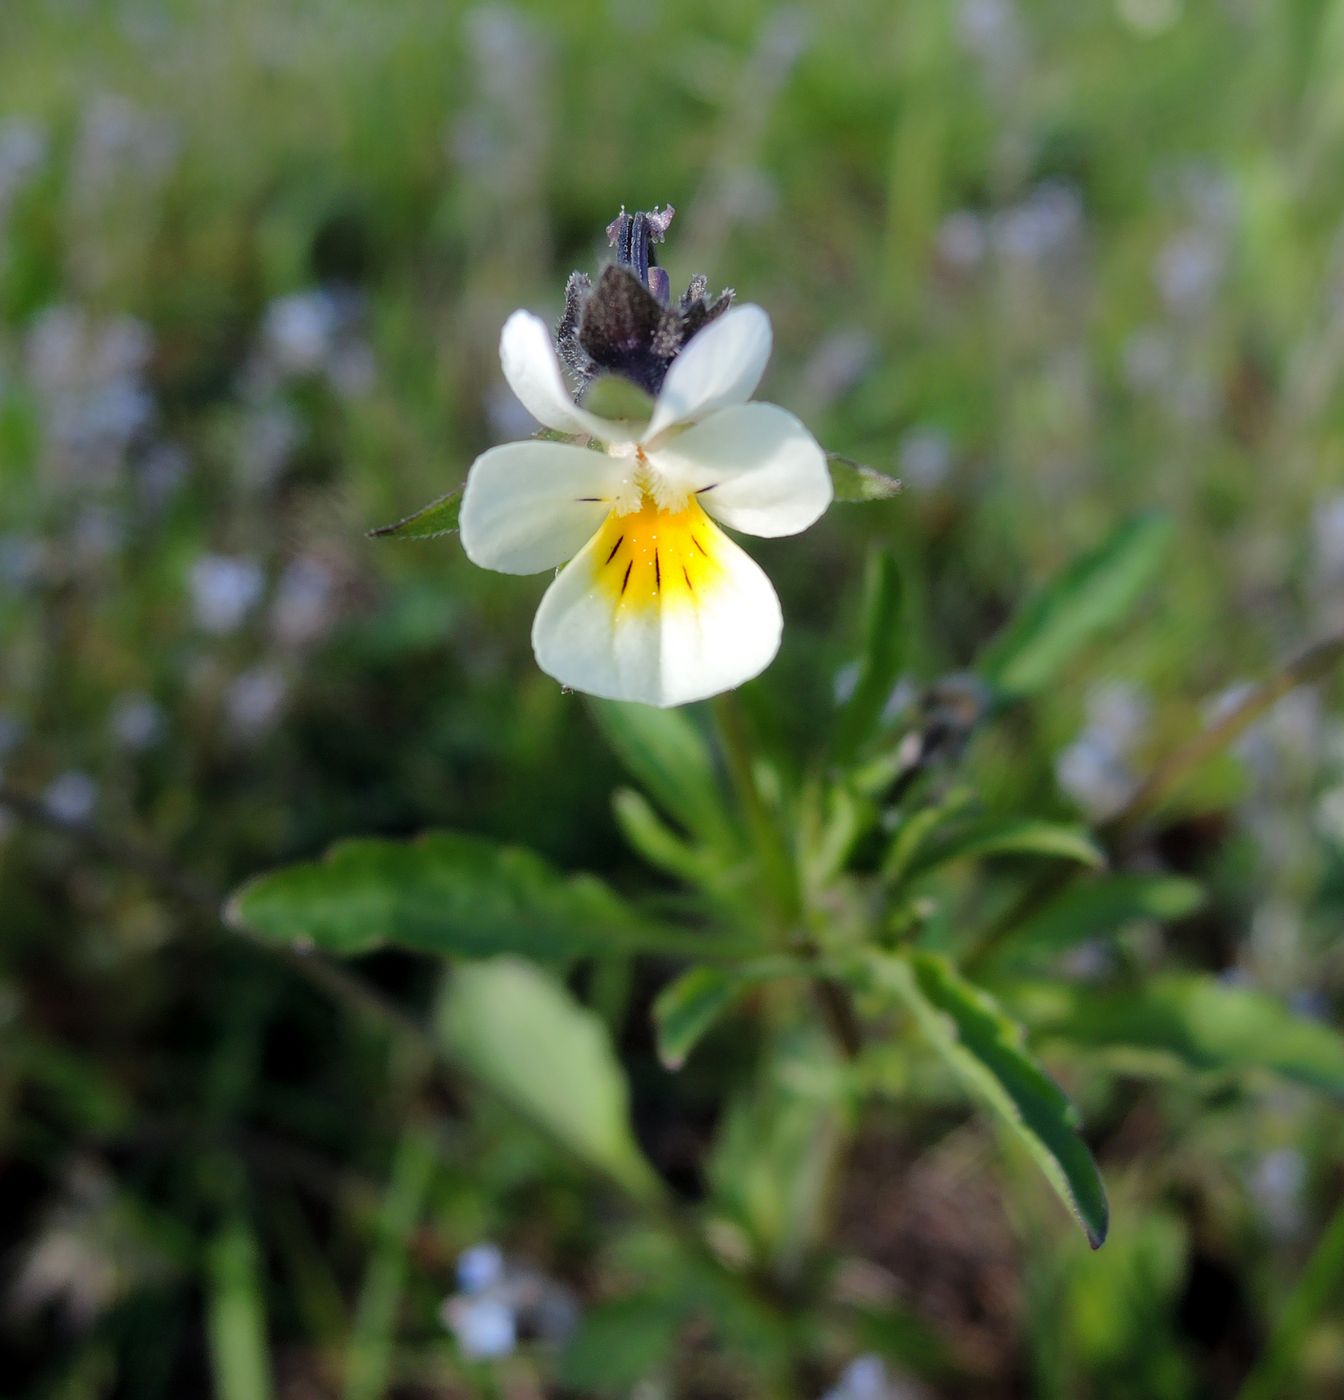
<box><xmin>0</xmin><ymin>0</ymin><xmax>1344</xmax><ymax>1400</ymax></box>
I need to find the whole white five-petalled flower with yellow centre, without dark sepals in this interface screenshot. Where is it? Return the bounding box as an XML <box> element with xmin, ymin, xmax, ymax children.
<box><xmin>461</xmin><ymin>305</ymin><xmax>832</xmax><ymax>706</ymax></box>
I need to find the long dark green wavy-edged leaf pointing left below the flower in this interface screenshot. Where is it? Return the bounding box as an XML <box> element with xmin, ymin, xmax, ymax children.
<box><xmin>227</xmin><ymin>832</ymin><xmax>729</xmax><ymax>960</ymax></box>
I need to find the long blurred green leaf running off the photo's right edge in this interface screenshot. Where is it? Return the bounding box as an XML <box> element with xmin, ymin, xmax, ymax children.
<box><xmin>1004</xmin><ymin>974</ymin><xmax>1344</xmax><ymax>1096</ymax></box>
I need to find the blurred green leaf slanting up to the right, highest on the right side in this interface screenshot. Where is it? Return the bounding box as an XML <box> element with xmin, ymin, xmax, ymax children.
<box><xmin>980</xmin><ymin>515</ymin><xmax>1172</xmax><ymax>696</ymax></box>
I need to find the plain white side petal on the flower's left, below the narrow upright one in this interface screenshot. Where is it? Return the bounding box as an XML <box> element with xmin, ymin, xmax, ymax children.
<box><xmin>458</xmin><ymin>442</ymin><xmax>629</xmax><ymax>574</ymax></box>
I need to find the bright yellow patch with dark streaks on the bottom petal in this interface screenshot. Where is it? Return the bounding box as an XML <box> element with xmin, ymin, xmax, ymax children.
<box><xmin>594</xmin><ymin>496</ymin><xmax>722</xmax><ymax>609</ymax></box>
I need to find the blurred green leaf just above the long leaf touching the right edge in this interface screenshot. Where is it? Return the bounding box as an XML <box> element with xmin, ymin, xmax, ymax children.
<box><xmin>990</xmin><ymin>872</ymin><xmax>1204</xmax><ymax>969</ymax></box>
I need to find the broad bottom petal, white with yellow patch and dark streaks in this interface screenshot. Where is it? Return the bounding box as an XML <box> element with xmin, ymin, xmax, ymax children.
<box><xmin>532</xmin><ymin>503</ymin><xmax>783</xmax><ymax>706</ymax></box>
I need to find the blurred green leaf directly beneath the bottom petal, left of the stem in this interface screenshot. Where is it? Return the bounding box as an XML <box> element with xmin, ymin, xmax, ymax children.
<box><xmin>592</xmin><ymin>700</ymin><xmax>725</xmax><ymax>839</ymax></box>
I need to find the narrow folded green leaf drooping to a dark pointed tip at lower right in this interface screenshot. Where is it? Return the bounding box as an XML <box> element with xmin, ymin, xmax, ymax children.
<box><xmin>867</xmin><ymin>952</ymin><xmax>1109</xmax><ymax>1249</ymax></box>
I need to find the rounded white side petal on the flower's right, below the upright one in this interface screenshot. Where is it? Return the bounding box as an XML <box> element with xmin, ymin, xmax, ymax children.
<box><xmin>647</xmin><ymin>403</ymin><xmax>833</xmax><ymax>538</ymax></box>
